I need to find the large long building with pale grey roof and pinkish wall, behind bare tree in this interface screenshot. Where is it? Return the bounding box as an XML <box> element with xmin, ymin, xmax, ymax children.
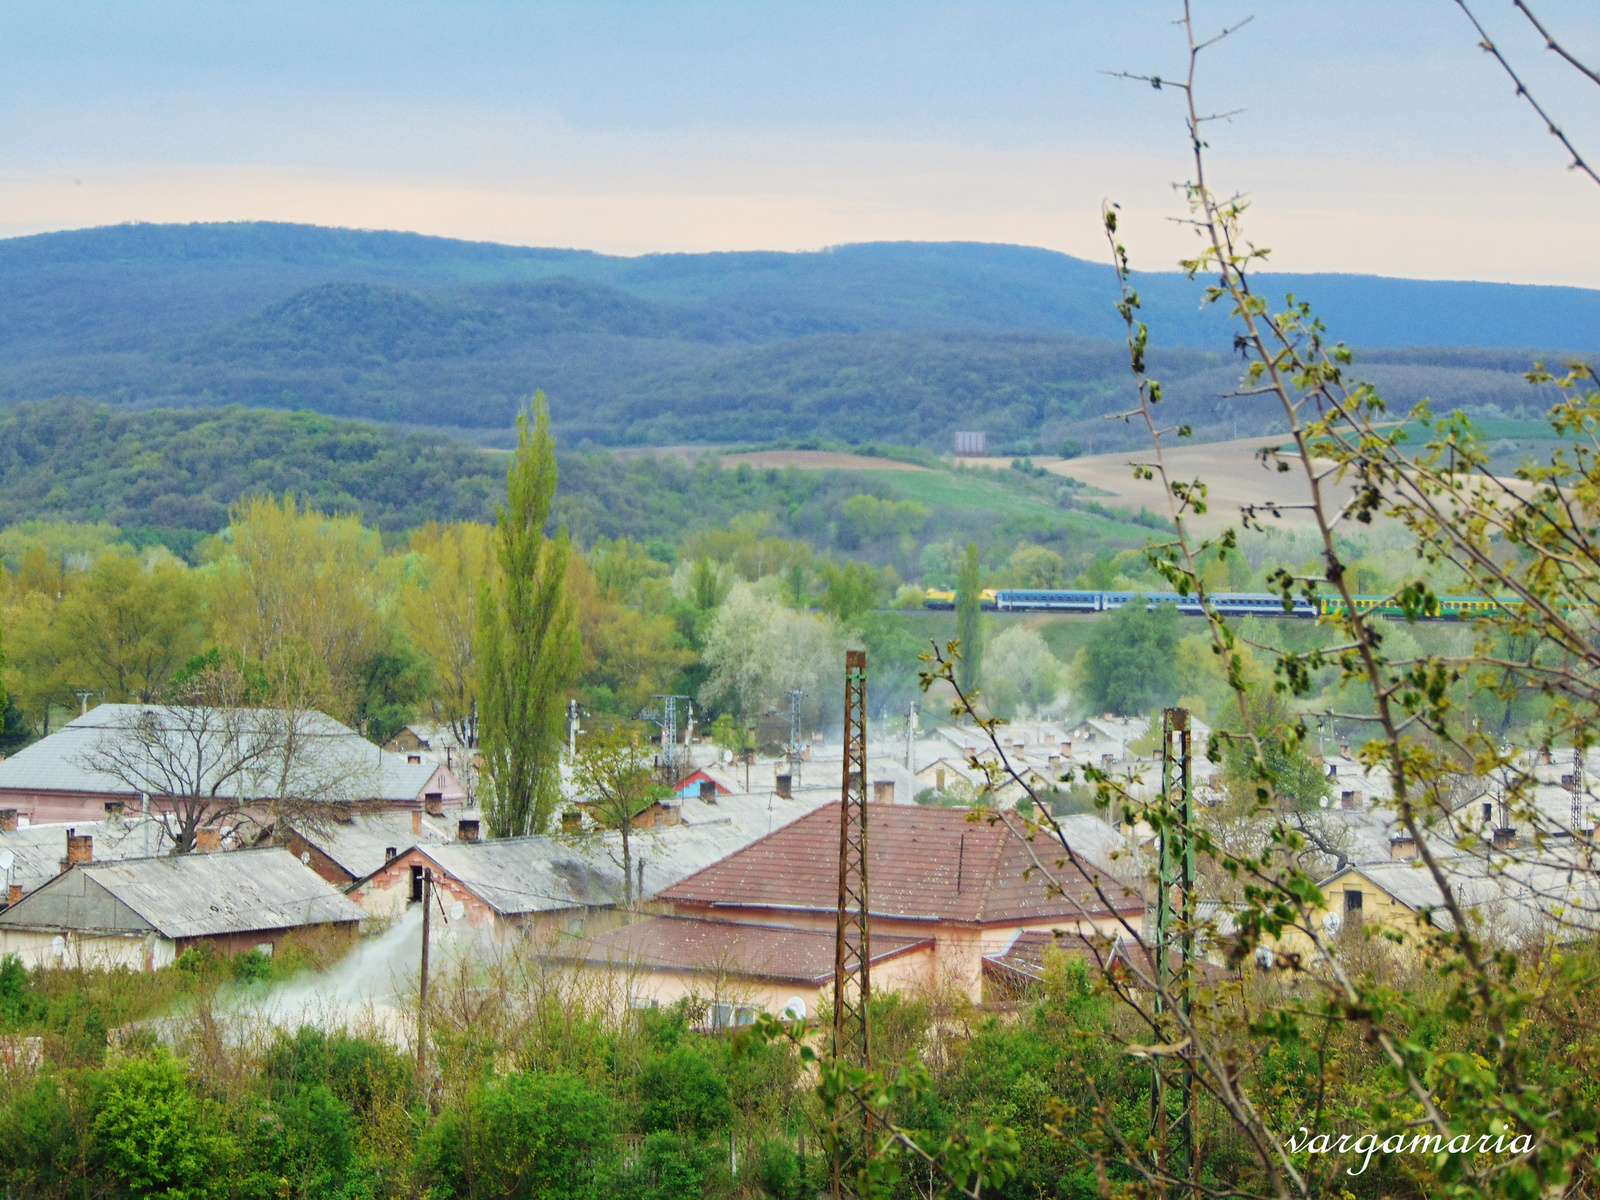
<box><xmin>0</xmin><ymin>704</ymin><xmax>466</xmax><ymax>824</ymax></box>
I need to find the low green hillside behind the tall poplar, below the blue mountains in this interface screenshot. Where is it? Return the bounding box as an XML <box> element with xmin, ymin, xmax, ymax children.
<box><xmin>0</xmin><ymin>400</ymin><xmax>1149</xmax><ymax>576</ymax></box>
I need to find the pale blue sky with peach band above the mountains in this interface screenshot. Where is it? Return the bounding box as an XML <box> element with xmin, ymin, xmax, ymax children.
<box><xmin>0</xmin><ymin>0</ymin><xmax>1600</xmax><ymax>286</ymax></box>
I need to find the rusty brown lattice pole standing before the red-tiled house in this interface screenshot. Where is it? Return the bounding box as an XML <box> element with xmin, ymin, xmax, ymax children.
<box><xmin>832</xmin><ymin>650</ymin><xmax>872</xmax><ymax>1200</ymax></box>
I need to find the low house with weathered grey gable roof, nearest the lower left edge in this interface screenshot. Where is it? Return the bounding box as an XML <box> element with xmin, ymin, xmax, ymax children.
<box><xmin>0</xmin><ymin>846</ymin><xmax>365</xmax><ymax>971</ymax></box>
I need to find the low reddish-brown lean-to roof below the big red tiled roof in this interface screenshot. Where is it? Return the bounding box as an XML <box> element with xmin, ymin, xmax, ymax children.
<box><xmin>576</xmin><ymin>917</ymin><xmax>933</xmax><ymax>986</ymax></box>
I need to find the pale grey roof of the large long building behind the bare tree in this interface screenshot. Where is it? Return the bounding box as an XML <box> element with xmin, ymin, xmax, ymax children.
<box><xmin>0</xmin><ymin>704</ymin><xmax>461</xmax><ymax>802</ymax></box>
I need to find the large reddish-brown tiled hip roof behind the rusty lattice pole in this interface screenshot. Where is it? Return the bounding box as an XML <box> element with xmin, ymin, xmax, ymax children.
<box><xmin>658</xmin><ymin>805</ymin><xmax>1144</xmax><ymax>923</ymax></box>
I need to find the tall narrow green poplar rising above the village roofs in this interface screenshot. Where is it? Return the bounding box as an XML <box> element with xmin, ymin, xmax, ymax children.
<box><xmin>478</xmin><ymin>400</ymin><xmax>582</xmax><ymax>837</ymax></box>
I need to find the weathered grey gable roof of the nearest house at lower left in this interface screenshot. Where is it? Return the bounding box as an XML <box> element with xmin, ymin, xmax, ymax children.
<box><xmin>0</xmin><ymin>846</ymin><xmax>366</xmax><ymax>939</ymax></box>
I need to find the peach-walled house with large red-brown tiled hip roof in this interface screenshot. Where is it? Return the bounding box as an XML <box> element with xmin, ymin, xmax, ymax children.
<box><xmin>656</xmin><ymin>805</ymin><xmax>1144</xmax><ymax>1000</ymax></box>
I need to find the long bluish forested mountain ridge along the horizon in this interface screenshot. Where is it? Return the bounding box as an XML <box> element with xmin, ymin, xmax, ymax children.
<box><xmin>0</xmin><ymin>224</ymin><xmax>1600</xmax><ymax>450</ymax></box>
